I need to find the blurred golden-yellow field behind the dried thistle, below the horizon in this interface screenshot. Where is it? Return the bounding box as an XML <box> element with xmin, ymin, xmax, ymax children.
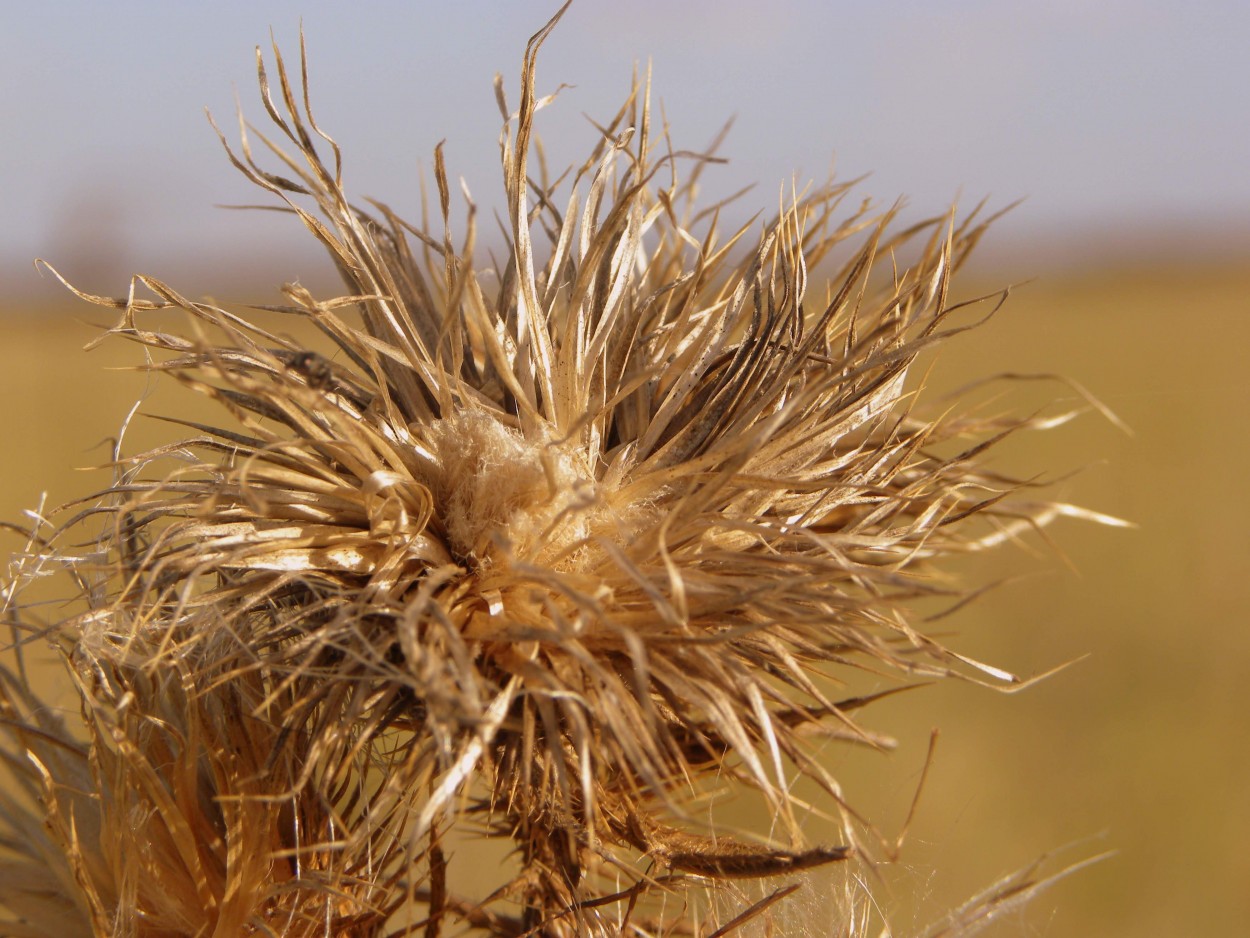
<box><xmin>0</xmin><ymin>253</ymin><xmax>1250</xmax><ymax>938</ymax></box>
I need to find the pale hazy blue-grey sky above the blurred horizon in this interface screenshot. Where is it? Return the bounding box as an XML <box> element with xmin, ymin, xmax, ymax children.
<box><xmin>0</xmin><ymin>0</ymin><xmax>1250</xmax><ymax>291</ymax></box>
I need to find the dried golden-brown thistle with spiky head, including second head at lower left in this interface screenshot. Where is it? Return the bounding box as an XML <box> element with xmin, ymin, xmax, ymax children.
<box><xmin>0</xmin><ymin>7</ymin><xmax>1120</xmax><ymax>935</ymax></box>
